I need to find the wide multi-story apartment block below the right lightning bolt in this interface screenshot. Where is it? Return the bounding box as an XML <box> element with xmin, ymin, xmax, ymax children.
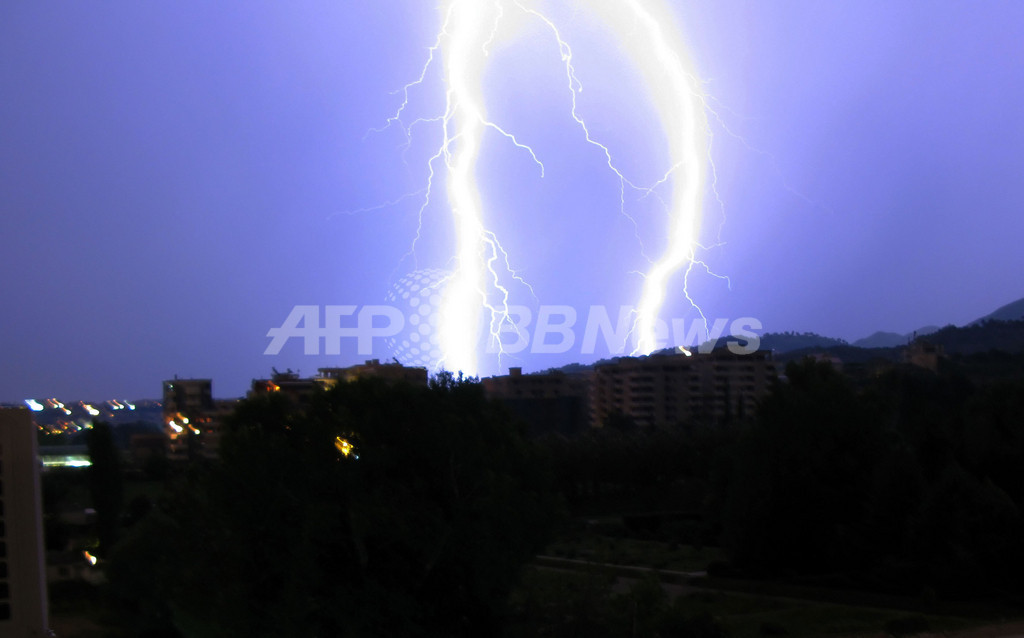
<box><xmin>590</xmin><ymin>348</ymin><xmax>776</xmax><ymax>427</ymax></box>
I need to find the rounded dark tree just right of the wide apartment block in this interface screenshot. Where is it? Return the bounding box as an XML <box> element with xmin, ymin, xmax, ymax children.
<box><xmin>726</xmin><ymin>359</ymin><xmax>886</xmax><ymax>573</ymax></box>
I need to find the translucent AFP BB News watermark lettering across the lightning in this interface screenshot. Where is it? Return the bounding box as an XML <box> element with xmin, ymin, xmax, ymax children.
<box><xmin>263</xmin><ymin>305</ymin><xmax>762</xmax><ymax>366</ymax></box>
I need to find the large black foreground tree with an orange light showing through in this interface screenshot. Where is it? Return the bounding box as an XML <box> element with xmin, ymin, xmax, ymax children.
<box><xmin>110</xmin><ymin>374</ymin><xmax>556</xmax><ymax>637</ymax></box>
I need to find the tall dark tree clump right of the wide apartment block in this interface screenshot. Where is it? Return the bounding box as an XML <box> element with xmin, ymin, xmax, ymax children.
<box><xmin>724</xmin><ymin>361</ymin><xmax>1024</xmax><ymax>597</ymax></box>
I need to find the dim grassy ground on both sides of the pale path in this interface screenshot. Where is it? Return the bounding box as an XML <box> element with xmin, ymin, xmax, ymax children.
<box><xmin>532</xmin><ymin>529</ymin><xmax>977</xmax><ymax>638</ymax></box>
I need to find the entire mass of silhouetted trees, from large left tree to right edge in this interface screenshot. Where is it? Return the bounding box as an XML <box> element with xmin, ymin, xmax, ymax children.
<box><xmin>95</xmin><ymin>360</ymin><xmax>1024</xmax><ymax>637</ymax></box>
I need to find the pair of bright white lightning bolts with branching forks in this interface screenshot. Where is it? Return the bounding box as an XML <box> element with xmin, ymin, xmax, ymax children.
<box><xmin>378</xmin><ymin>0</ymin><xmax>710</xmax><ymax>374</ymax></box>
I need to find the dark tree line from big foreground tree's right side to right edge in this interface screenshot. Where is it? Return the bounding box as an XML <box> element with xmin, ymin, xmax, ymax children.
<box><xmin>545</xmin><ymin>360</ymin><xmax>1024</xmax><ymax>597</ymax></box>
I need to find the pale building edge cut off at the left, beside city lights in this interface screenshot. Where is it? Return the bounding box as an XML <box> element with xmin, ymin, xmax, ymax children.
<box><xmin>0</xmin><ymin>409</ymin><xmax>48</xmax><ymax>638</ymax></box>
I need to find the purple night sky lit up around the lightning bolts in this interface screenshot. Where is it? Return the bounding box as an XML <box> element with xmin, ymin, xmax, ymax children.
<box><xmin>0</xmin><ymin>0</ymin><xmax>1024</xmax><ymax>401</ymax></box>
